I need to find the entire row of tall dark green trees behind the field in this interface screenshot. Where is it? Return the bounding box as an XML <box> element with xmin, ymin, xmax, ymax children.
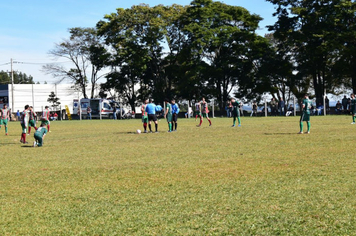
<box><xmin>44</xmin><ymin>0</ymin><xmax>356</xmax><ymax>109</ymax></box>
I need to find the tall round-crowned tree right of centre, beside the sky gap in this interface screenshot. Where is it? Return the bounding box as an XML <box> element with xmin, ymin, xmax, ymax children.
<box><xmin>183</xmin><ymin>0</ymin><xmax>261</xmax><ymax>109</ymax></box>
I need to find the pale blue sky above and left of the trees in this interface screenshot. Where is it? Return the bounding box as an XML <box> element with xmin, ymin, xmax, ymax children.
<box><xmin>0</xmin><ymin>0</ymin><xmax>275</xmax><ymax>84</ymax></box>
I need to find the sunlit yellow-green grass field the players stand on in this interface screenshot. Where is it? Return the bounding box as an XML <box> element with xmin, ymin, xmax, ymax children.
<box><xmin>0</xmin><ymin>116</ymin><xmax>356</xmax><ymax>235</ymax></box>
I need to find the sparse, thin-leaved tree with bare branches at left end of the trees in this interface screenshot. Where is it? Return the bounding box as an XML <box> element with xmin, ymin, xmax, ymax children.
<box><xmin>43</xmin><ymin>27</ymin><xmax>110</xmax><ymax>98</ymax></box>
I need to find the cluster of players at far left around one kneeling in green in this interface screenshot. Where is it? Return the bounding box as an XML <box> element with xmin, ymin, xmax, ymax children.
<box><xmin>20</xmin><ymin>105</ymin><xmax>51</xmax><ymax>147</ymax></box>
